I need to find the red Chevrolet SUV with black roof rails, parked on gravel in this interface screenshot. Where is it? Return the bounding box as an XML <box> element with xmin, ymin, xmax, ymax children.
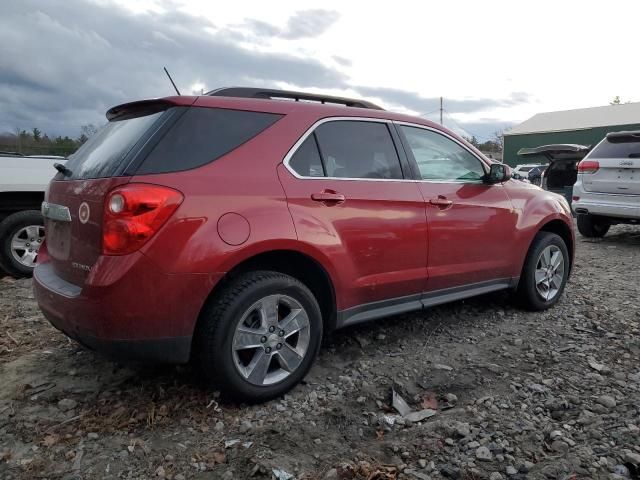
<box><xmin>34</xmin><ymin>88</ymin><xmax>574</xmax><ymax>401</ymax></box>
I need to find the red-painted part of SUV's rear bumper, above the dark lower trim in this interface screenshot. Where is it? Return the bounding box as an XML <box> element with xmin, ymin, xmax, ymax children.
<box><xmin>34</xmin><ymin>246</ymin><xmax>222</xmax><ymax>340</ymax></box>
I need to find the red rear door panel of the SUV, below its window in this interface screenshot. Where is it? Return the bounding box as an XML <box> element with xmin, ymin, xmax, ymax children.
<box><xmin>278</xmin><ymin>166</ymin><xmax>427</xmax><ymax>310</ymax></box>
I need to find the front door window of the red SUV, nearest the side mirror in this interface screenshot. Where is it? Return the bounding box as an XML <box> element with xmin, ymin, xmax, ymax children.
<box><xmin>400</xmin><ymin>126</ymin><xmax>486</xmax><ymax>182</ymax></box>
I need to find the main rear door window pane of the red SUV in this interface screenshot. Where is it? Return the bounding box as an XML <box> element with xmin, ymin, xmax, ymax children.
<box><xmin>315</xmin><ymin>120</ymin><xmax>402</xmax><ymax>179</ymax></box>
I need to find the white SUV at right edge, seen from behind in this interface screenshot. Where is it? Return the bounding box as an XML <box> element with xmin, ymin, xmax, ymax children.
<box><xmin>572</xmin><ymin>131</ymin><xmax>640</xmax><ymax>237</ymax></box>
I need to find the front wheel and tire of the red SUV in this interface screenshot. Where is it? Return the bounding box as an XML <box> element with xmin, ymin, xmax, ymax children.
<box><xmin>516</xmin><ymin>232</ymin><xmax>570</xmax><ymax>311</ymax></box>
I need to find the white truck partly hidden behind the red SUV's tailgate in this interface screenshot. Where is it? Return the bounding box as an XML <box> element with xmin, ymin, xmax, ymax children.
<box><xmin>0</xmin><ymin>153</ymin><xmax>66</xmax><ymax>277</ymax></box>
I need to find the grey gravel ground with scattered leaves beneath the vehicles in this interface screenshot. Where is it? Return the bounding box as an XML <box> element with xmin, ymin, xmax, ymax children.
<box><xmin>0</xmin><ymin>226</ymin><xmax>640</xmax><ymax>480</ymax></box>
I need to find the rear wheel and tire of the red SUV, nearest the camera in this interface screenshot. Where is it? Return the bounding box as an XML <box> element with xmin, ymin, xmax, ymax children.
<box><xmin>194</xmin><ymin>271</ymin><xmax>322</xmax><ymax>403</ymax></box>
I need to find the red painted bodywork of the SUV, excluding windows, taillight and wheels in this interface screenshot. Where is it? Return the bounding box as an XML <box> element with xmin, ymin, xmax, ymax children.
<box><xmin>34</xmin><ymin>96</ymin><xmax>573</xmax><ymax>364</ymax></box>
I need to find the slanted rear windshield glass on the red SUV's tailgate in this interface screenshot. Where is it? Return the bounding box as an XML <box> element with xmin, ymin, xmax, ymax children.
<box><xmin>62</xmin><ymin>112</ymin><xmax>163</xmax><ymax>180</ymax></box>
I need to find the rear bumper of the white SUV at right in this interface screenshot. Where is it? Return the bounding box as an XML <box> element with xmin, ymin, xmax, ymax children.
<box><xmin>571</xmin><ymin>184</ymin><xmax>640</xmax><ymax>219</ymax></box>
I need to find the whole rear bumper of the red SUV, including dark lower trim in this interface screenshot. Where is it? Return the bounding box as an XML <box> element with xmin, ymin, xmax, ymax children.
<box><xmin>33</xmin><ymin>253</ymin><xmax>222</xmax><ymax>363</ymax></box>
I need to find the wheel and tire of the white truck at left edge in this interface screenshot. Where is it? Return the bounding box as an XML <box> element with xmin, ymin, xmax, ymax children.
<box><xmin>0</xmin><ymin>210</ymin><xmax>44</xmax><ymax>278</ymax></box>
